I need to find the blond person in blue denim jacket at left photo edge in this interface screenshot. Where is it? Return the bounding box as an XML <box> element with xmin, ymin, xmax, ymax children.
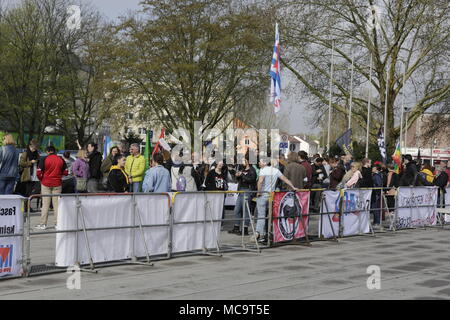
<box><xmin>0</xmin><ymin>134</ymin><xmax>19</xmax><ymax>195</ymax></box>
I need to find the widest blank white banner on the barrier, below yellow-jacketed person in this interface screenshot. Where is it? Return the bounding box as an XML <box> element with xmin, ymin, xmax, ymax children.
<box><xmin>55</xmin><ymin>195</ymin><xmax>170</xmax><ymax>267</ymax></box>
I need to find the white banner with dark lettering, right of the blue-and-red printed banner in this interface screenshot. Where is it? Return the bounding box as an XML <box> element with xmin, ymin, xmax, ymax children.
<box><xmin>395</xmin><ymin>187</ymin><xmax>438</xmax><ymax>229</ymax></box>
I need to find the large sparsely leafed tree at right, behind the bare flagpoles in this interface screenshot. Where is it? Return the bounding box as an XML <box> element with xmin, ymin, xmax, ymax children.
<box><xmin>279</xmin><ymin>0</ymin><xmax>450</xmax><ymax>154</ymax></box>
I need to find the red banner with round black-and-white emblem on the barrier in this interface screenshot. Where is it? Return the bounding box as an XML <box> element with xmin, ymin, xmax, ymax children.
<box><xmin>272</xmin><ymin>192</ymin><xmax>310</xmax><ymax>243</ymax></box>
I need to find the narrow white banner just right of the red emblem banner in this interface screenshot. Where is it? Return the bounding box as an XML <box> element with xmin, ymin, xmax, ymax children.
<box><xmin>319</xmin><ymin>190</ymin><xmax>341</xmax><ymax>239</ymax></box>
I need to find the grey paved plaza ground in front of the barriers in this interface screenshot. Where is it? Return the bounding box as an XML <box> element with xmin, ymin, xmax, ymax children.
<box><xmin>0</xmin><ymin>210</ymin><xmax>450</xmax><ymax>300</ymax></box>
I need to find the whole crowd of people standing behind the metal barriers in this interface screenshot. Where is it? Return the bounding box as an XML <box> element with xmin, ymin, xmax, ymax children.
<box><xmin>0</xmin><ymin>134</ymin><xmax>450</xmax><ymax>235</ymax></box>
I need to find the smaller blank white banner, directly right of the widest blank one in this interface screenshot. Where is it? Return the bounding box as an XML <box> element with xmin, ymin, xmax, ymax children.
<box><xmin>172</xmin><ymin>193</ymin><xmax>224</xmax><ymax>253</ymax></box>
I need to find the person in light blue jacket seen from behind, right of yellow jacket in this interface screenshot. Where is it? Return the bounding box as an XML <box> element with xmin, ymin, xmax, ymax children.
<box><xmin>142</xmin><ymin>153</ymin><xmax>171</xmax><ymax>193</ymax></box>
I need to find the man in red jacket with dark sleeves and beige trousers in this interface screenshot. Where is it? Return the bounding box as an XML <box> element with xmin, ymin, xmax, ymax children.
<box><xmin>36</xmin><ymin>146</ymin><xmax>68</xmax><ymax>230</ymax></box>
